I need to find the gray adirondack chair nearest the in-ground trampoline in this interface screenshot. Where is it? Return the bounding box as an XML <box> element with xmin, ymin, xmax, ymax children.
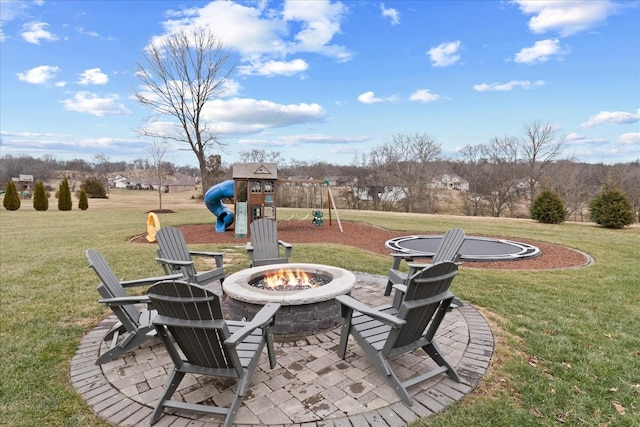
<box><xmin>384</xmin><ymin>228</ymin><xmax>465</xmax><ymax>295</ymax></box>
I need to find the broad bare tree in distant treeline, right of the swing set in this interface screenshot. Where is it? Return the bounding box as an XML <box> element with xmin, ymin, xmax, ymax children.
<box><xmin>381</xmin><ymin>133</ymin><xmax>441</xmax><ymax>212</ymax></box>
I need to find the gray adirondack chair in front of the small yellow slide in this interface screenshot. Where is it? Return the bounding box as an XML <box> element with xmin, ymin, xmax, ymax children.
<box><xmin>156</xmin><ymin>227</ymin><xmax>225</xmax><ymax>286</ymax></box>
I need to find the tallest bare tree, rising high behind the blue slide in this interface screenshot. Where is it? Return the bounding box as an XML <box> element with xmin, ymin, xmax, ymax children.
<box><xmin>134</xmin><ymin>28</ymin><xmax>234</xmax><ymax>190</ymax></box>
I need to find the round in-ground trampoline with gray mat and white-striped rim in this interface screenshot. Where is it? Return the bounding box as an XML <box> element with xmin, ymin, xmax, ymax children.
<box><xmin>385</xmin><ymin>235</ymin><xmax>542</xmax><ymax>262</ymax></box>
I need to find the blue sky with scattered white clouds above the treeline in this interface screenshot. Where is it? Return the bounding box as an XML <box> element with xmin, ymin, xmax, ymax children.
<box><xmin>0</xmin><ymin>0</ymin><xmax>640</xmax><ymax>165</ymax></box>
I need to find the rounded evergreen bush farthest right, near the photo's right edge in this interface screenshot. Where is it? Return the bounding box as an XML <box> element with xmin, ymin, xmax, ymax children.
<box><xmin>589</xmin><ymin>179</ymin><xmax>635</xmax><ymax>228</ymax></box>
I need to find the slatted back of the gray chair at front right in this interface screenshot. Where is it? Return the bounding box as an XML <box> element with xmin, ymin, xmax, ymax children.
<box><xmin>383</xmin><ymin>261</ymin><xmax>458</xmax><ymax>354</ymax></box>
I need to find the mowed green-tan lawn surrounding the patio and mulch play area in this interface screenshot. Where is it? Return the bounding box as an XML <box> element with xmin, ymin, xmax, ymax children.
<box><xmin>0</xmin><ymin>191</ymin><xmax>640</xmax><ymax>426</ymax></box>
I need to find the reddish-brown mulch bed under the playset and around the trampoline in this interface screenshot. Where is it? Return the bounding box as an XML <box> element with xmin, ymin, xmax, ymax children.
<box><xmin>134</xmin><ymin>220</ymin><xmax>589</xmax><ymax>270</ymax></box>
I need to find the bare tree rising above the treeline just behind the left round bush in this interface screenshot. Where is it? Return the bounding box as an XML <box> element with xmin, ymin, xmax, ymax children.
<box><xmin>520</xmin><ymin>121</ymin><xmax>566</xmax><ymax>204</ymax></box>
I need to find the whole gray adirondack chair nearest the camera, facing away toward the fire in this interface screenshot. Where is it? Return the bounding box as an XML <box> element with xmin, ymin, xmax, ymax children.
<box><xmin>147</xmin><ymin>281</ymin><xmax>280</xmax><ymax>427</ymax></box>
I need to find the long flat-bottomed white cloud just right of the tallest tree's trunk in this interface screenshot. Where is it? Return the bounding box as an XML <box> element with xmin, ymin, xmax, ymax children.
<box><xmin>202</xmin><ymin>98</ymin><xmax>326</xmax><ymax>134</ymax></box>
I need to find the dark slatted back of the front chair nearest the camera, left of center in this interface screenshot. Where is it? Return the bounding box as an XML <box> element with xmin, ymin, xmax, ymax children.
<box><xmin>147</xmin><ymin>281</ymin><xmax>242</xmax><ymax>376</ymax></box>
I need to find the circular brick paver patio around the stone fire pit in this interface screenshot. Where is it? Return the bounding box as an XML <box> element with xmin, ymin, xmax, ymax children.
<box><xmin>70</xmin><ymin>273</ymin><xmax>494</xmax><ymax>427</ymax></box>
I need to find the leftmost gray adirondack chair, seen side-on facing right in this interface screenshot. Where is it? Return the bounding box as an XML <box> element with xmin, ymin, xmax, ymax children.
<box><xmin>85</xmin><ymin>249</ymin><xmax>182</xmax><ymax>365</ymax></box>
